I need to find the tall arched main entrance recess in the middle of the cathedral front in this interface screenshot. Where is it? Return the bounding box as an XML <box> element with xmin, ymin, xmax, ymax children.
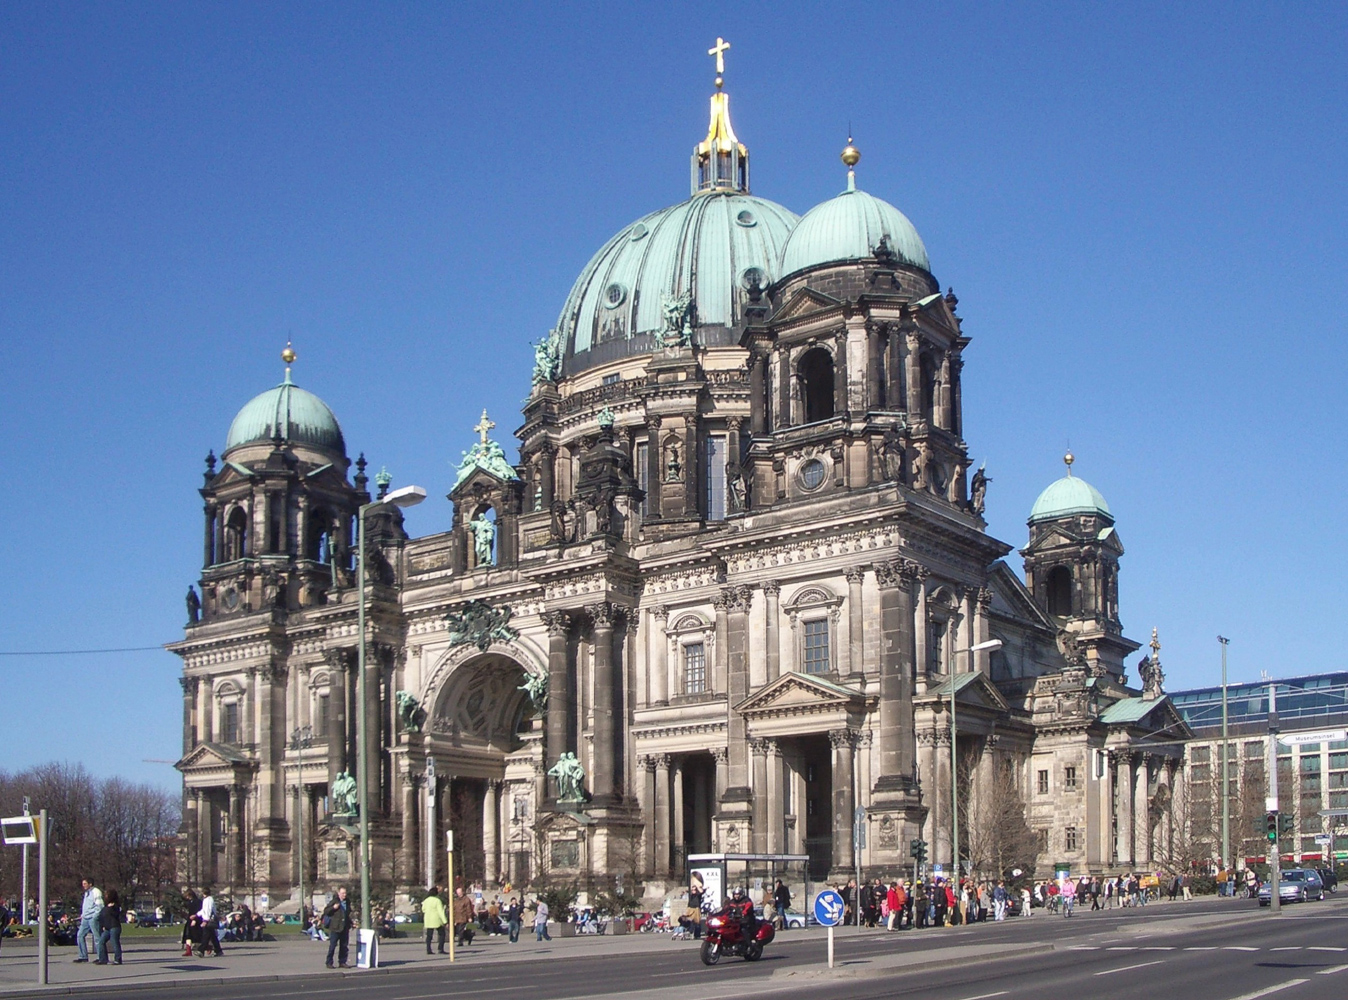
<box><xmin>426</xmin><ymin>651</ymin><xmax>542</xmax><ymax>885</ymax></box>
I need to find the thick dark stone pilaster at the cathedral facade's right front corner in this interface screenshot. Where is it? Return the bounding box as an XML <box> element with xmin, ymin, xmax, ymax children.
<box><xmin>875</xmin><ymin>559</ymin><xmax>930</xmax><ymax>795</ymax></box>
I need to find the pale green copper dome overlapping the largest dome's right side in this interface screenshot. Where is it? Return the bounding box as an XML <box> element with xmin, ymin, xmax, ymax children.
<box><xmin>782</xmin><ymin>189</ymin><xmax>931</xmax><ymax>275</ymax></box>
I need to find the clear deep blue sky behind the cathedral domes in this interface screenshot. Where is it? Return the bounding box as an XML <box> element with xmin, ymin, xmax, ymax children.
<box><xmin>0</xmin><ymin>3</ymin><xmax>1348</xmax><ymax>786</ymax></box>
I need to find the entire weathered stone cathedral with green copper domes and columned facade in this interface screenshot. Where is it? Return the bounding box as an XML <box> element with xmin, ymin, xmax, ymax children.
<box><xmin>171</xmin><ymin>56</ymin><xmax>1184</xmax><ymax>907</ymax></box>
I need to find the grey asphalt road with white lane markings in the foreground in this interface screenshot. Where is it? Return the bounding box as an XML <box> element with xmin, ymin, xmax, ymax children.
<box><xmin>34</xmin><ymin>894</ymin><xmax>1348</xmax><ymax>1000</ymax></box>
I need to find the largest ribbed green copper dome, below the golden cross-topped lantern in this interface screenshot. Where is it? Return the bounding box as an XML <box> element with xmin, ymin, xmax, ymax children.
<box><xmin>557</xmin><ymin>190</ymin><xmax>797</xmax><ymax>375</ymax></box>
